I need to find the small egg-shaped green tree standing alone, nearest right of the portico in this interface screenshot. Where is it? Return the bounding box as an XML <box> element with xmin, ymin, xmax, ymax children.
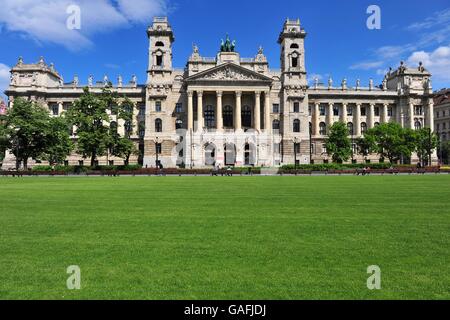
<box><xmin>326</xmin><ymin>122</ymin><xmax>352</xmax><ymax>163</ymax></box>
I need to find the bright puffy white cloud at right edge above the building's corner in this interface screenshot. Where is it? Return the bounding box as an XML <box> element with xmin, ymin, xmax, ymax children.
<box><xmin>407</xmin><ymin>45</ymin><xmax>450</xmax><ymax>82</ymax></box>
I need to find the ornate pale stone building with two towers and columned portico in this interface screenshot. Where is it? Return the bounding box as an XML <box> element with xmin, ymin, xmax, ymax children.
<box><xmin>2</xmin><ymin>17</ymin><xmax>434</xmax><ymax>168</ymax></box>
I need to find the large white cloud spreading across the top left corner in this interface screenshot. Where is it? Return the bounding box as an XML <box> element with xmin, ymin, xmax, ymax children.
<box><xmin>0</xmin><ymin>0</ymin><xmax>166</xmax><ymax>50</ymax></box>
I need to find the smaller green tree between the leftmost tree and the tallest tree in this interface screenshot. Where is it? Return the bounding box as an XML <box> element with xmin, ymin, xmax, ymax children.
<box><xmin>42</xmin><ymin>117</ymin><xmax>73</xmax><ymax>165</ymax></box>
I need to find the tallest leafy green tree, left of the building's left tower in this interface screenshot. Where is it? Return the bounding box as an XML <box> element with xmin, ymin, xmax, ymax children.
<box><xmin>67</xmin><ymin>88</ymin><xmax>116</xmax><ymax>166</ymax></box>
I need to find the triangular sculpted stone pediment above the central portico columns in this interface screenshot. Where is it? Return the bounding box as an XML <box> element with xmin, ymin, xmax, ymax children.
<box><xmin>186</xmin><ymin>63</ymin><xmax>272</xmax><ymax>83</ymax></box>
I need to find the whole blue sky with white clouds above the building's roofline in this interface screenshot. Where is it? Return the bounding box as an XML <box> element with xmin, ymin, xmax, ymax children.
<box><xmin>0</xmin><ymin>0</ymin><xmax>450</xmax><ymax>100</ymax></box>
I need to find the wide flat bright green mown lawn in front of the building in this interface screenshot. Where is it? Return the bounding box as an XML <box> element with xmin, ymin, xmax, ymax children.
<box><xmin>0</xmin><ymin>175</ymin><xmax>450</xmax><ymax>299</ymax></box>
